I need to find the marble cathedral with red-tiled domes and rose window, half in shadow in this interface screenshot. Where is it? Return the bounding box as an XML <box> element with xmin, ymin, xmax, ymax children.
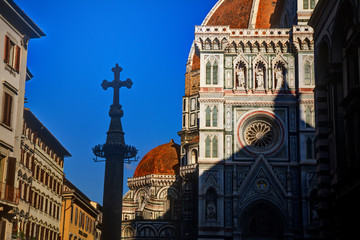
<box><xmin>122</xmin><ymin>0</ymin><xmax>319</xmax><ymax>239</ymax></box>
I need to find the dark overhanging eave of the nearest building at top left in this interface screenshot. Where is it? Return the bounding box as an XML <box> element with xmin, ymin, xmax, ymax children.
<box><xmin>0</xmin><ymin>0</ymin><xmax>46</xmax><ymax>38</ymax></box>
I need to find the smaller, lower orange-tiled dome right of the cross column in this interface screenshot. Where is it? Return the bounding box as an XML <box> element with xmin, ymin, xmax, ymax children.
<box><xmin>134</xmin><ymin>140</ymin><xmax>180</xmax><ymax>178</ymax></box>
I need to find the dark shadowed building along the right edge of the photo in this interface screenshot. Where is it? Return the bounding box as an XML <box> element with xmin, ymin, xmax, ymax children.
<box><xmin>310</xmin><ymin>0</ymin><xmax>360</xmax><ymax>239</ymax></box>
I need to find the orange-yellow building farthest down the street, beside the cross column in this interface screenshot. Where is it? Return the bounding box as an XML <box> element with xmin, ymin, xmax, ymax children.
<box><xmin>60</xmin><ymin>178</ymin><xmax>102</xmax><ymax>240</ymax></box>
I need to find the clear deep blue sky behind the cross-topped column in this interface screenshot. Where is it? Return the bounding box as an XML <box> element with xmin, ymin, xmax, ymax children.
<box><xmin>15</xmin><ymin>0</ymin><xmax>217</xmax><ymax>203</ymax></box>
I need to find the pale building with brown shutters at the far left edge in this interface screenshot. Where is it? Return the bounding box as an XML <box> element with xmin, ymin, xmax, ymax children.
<box><xmin>0</xmin><ymin>0</ymin><xmax>45</xmax><ymax>239</ymax></box>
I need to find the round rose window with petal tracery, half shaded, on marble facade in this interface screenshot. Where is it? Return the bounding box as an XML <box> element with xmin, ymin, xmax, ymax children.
<box><xmin>245</xmin><ymin>121</ymin><xmax>273</xmax><ymax>150</ymax></box>
